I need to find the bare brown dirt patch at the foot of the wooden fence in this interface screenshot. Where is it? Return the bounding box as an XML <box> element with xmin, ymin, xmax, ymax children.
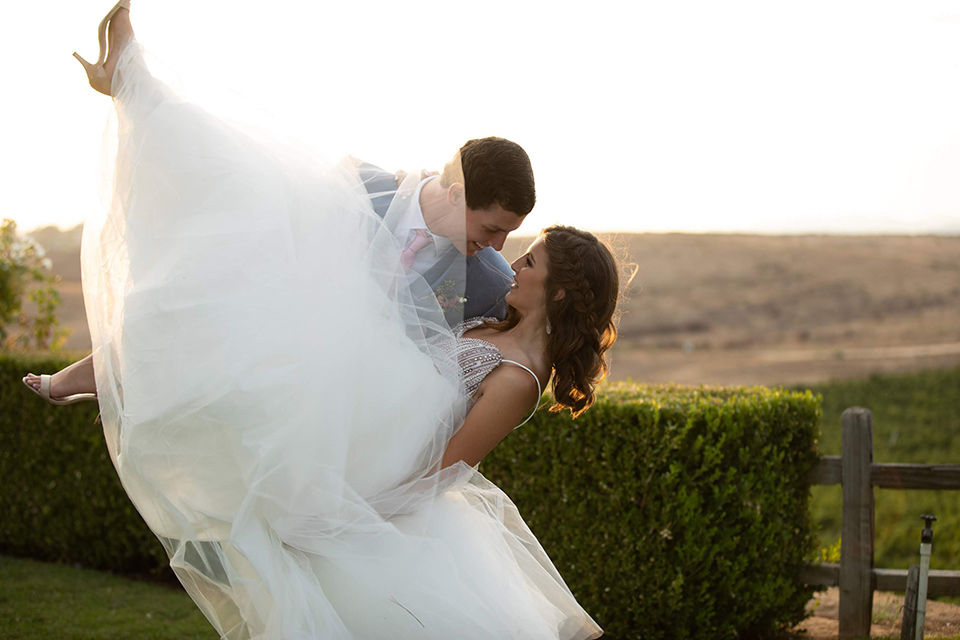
<box><xmin>787</xmin><ymin>587</ymin><xmax>960</xmax><ymax>640</ymax></box>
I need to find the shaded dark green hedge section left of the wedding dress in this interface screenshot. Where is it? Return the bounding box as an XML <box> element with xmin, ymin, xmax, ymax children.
<box><xmin>0</xmin><ymin>354</ymin><xmax>172</xmax><ymax>577</ymax></box>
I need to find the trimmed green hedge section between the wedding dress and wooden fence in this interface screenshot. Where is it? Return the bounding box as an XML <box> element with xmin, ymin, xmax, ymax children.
<box><xmin>482</xmin><ymin>384</ymin><xmax>819</xmax><ymax>640</ymax></box>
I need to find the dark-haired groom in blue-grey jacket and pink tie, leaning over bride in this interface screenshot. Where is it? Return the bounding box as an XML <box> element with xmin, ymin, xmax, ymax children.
<box><xmin>357</xmin><ymin>137</ymin><xmax>536</xmax><ymax>319</ymax></box>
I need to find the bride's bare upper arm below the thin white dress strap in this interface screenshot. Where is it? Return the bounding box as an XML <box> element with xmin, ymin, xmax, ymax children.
<box><xmin>443</xmin><ymin>366</ymin><xmax>540</xmax><ymax>467</ymax></box>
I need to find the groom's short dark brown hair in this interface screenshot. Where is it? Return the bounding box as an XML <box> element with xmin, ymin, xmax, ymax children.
<box><xmin>440</xmin><ymin>137</ymin><xmax>537</xmax><ymax>216</ymax></box>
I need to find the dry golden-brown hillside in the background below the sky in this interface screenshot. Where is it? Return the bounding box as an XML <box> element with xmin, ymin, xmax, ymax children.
<box><xmin>35</xmin><ymin>230</ymin><xmax>960</xmax><ymax>385</ymax></box>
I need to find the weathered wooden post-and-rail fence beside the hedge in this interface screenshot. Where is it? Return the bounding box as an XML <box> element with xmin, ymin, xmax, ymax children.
<box><xmin>801</xmin><ymin>407</ymin><xmax>960</xmax><ymax>639</ymax></box>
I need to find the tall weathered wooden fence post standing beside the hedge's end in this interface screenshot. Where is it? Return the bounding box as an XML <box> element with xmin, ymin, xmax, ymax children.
<box><xmin>840</xmin><ymin>407</ymin><xmax>873</xmax><ymax>639</ymax></box>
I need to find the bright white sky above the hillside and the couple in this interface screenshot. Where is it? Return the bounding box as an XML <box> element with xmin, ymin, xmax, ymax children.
<box><xmin>0</xmin><ymin>0</ymin><xmax>960</xmax><ymax>233</ymax></box>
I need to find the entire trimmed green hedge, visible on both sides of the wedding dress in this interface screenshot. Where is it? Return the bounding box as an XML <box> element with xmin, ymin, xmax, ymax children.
<box><xmin>0</xmin><ymin>358</ymin><xmax>820</xmax><ymax>640</ymax></box>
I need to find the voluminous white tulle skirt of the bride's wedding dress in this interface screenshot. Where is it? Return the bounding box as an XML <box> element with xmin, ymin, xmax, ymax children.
<box><xmin>83</xmin><ymin>43</ymin><xmax>601</xmax><ymax>640</ymax></box>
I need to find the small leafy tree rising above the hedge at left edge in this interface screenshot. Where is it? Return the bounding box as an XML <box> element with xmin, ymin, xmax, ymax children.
<box><xmin>0</xmin><ymin>219</ymin><xmax>66</xmax><ymax>349</ymax></box>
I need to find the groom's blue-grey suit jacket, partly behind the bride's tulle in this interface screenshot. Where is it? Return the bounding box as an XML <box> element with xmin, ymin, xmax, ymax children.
<box><xmin>357</xmin><ymin>163</ymin><xmax>513</xmax><ymax>320</ymax></box>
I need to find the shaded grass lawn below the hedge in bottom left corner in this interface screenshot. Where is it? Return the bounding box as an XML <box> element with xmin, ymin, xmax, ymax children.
<box><xmin>0</xmin><ymin>556</ymin><xmax>218</xmax><ymax>640</ymax></box>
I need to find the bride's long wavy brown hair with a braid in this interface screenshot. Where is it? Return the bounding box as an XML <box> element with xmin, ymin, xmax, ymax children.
<box><xmin>489</xmin><ymin>225</ymin><xmax>620</xmax><ymax>417</ymax></box>
